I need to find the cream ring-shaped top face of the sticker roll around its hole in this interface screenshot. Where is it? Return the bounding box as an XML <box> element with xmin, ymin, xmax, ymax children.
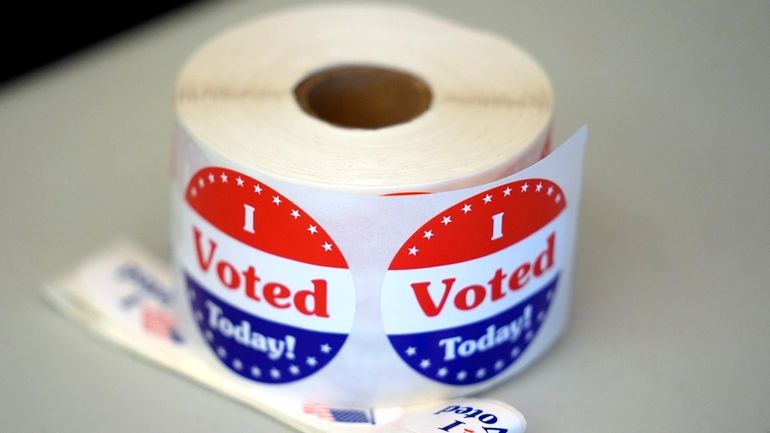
<box><xmin>177</xmin><ymin>5</ymin><xmax>553</xmax><ymax>194</ymax></box>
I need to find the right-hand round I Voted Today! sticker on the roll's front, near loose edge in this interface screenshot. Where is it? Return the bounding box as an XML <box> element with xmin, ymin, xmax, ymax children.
<box><xmin>382</xmin><ymin>179</ymin><xmax>569</xmax><ymax>385</ymax></box>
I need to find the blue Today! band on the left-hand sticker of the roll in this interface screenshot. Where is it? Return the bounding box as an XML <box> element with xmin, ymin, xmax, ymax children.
<box><xmin>185</xmin><ymin>274</ymin><xmax>347</xmax><ymax>384</ymax></box>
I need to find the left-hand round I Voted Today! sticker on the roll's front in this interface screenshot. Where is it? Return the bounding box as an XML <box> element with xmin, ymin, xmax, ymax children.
<box><xmin>178</xmin><ymin>167</ymin><xmax>355</xmax><ymax>384</ymax></box>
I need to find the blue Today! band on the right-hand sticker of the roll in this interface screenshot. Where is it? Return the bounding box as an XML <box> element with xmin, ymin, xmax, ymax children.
<box><xmin>388</xmin><ymin>274</ymin><xmax>559</xmax><ymax>385</ymax></box>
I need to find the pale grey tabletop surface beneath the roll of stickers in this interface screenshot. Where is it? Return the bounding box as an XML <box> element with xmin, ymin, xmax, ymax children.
<box><xmin>0</xmin><ymin>0</ymin><xmax>770</xmax><ymax>433</ymax></box>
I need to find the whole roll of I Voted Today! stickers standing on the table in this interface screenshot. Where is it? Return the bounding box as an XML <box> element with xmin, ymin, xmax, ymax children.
<box><xmin>172</xmin><ymin>5</ymin><xmax>582</xmax><ymax>408</ymax></box>
